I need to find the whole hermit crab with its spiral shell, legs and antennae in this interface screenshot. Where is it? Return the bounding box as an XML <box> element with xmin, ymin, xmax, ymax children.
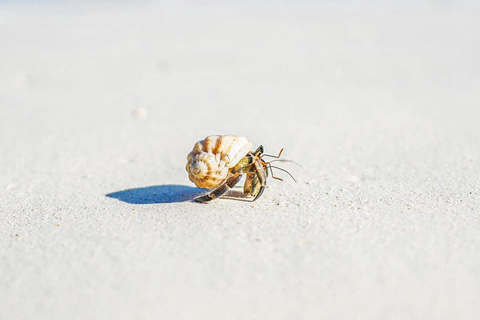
<box><xmin>185</xmin><ymin>135</ymin><xmax>295</xmax><ymax>202</ymax></box>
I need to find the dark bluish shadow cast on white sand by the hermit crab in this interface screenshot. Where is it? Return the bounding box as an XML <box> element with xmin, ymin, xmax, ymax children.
<box><xmin>106</xmin><ymin>184</ymin><xmax>208</xmax><ymax>204</ymax></box>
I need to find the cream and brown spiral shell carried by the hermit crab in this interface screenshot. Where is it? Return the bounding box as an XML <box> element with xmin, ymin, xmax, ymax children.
<box><xmin>185</xmin><ymin>135</ymin><xmax>252</xmax><ymax>189</ymax></box>
